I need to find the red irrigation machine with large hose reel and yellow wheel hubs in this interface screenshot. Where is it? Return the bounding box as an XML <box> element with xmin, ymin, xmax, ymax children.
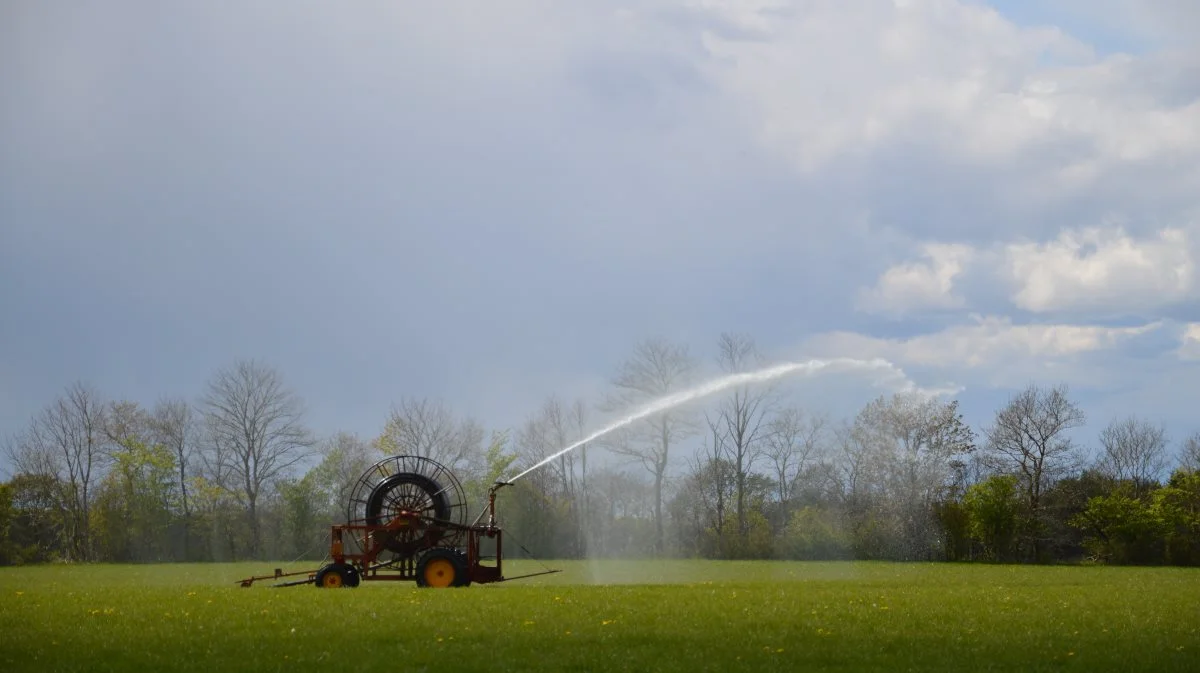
<box><xmin>240</xmin><ymin>456</ymin><xmax>559</xmax><ymax>588</ymax></box>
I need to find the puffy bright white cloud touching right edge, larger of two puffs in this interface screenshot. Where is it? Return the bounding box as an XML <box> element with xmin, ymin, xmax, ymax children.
<box><xmin>1006</xmin><ymin>228</ymin><xmax>1195</xmax><ymax>312</ymax></box>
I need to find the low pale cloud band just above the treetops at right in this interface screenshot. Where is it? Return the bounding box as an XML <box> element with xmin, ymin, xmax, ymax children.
<box><xmin>803</xmin><ymin>316</ymin><xmax>1200</xmax><ymax>440</ymax></box>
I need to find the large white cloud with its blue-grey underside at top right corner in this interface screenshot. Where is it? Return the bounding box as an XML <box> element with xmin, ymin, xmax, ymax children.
<box><xmin>686</xmin><ymin>0</ymin><xmax>1200</xmax><ymax>247</ymax></box>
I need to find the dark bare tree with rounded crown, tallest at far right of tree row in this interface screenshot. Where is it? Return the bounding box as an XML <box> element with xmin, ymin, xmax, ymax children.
<box><xmin>984</xmin><ymin>385</ymin><xmax>1086</xmax><ymax>559</ymax></box>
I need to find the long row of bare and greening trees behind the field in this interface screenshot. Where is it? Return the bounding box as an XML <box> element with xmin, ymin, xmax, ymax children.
<box><xmin>0</xmin><ymin>334</ymin><xmax>1200</xmax><ymax>565</ymax></box>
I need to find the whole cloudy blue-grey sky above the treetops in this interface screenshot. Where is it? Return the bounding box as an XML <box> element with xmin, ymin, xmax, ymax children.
<box><xmin>0</xmin><ymin>0</ymin><xmax>1200</xmax><ymax>475</ymax></box>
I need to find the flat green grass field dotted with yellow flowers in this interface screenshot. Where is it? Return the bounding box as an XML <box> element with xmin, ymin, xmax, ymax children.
<box><xmin>0</xmin><ymin>561</ymin><xmax>1200</xmax><ymax>673</ymax></box>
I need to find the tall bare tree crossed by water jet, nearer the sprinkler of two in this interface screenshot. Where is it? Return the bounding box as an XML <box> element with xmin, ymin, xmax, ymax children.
<box><xmin>602</xmin><ymin>338</ymin><xmax>696</xmax><ymax>554</ymax></box>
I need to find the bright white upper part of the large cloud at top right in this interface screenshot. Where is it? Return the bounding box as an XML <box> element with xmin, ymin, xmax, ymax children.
<box><xmin>686</xmin><ymin>0</ymin><xmax>1200</xmax><ymax>199</ymax></box>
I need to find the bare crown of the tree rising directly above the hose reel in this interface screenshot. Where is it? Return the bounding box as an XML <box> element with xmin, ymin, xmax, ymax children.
<box><xmin>374</xmin><ymin>397</ymin><xmax>485</xmax><ymax>469</ymax></box>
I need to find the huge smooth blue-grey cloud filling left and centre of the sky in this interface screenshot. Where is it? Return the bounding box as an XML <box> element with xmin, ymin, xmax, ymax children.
<box><xmin>0</xmin><ymin>2</ymin><xmax>1187</xmax><ymax>467</ymax></box>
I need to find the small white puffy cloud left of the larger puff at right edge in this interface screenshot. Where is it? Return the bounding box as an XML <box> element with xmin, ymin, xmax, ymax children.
<box><xmin>858</xmin><ymin>244</ymin><xmax>973</xmax><ymax>314</ymax></box>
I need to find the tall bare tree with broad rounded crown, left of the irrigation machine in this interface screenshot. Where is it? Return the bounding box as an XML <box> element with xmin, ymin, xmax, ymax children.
<box><xmin>203</xmin><ymin>361</ymin><xmax>313</xmax><ymax>557</ymax></box>
